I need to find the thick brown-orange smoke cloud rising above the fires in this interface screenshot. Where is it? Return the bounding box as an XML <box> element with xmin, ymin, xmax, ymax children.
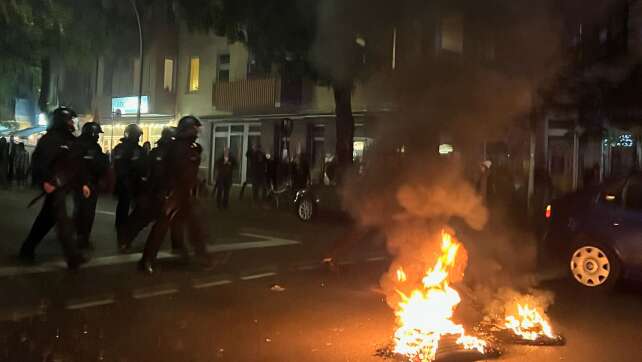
<box><xmin>342</xmin><ymin>1</ymin><xmax>563</xmax><ymax>320</ymax></box>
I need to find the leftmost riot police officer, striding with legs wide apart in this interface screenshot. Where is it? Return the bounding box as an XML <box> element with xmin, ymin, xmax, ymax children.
<box><xmin>20</xmin><ymin>107</ymin><xmax>91</xmax><ymax>270</ymax></box>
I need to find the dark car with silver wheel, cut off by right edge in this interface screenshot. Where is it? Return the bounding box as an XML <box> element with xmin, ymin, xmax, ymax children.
<box><xmin>540</xmin><ymin>174</ymin><xmax>642</xmax><ymax>290</ymax></box>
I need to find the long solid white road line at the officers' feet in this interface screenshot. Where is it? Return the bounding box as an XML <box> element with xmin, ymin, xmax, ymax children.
<box><xmin>0</xmin><ymin>233</ymin><xmax>301</xmax><ymax>277</ymax></box>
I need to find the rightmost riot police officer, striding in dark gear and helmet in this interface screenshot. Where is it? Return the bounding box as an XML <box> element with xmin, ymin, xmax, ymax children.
<box><xmin>138</xmin><ymin>116</ymin><xmax>211</xmax><ymax>274</ymax></box>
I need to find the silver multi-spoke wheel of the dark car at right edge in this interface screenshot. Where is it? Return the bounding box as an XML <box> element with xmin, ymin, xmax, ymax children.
<box><xmin>569</xmin><ymin>243</ymin><xmax>620</xmax><ymax>291</ymax></box>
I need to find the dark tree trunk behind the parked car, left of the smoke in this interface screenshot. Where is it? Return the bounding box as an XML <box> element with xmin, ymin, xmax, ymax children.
<box><xmin>332</xmin><ymin>84</ymin><xmax>354</xmax><ymax>180</ymax></box>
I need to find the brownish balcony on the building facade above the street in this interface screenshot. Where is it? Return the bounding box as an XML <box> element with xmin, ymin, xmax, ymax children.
<box><xmin>212</xmin><ymin>78</ymin><xmax>281</xmax><ymax>113</ymax></box>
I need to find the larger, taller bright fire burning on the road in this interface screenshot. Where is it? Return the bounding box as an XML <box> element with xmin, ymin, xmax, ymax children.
<box><xmin>394</xmin><ymin>231</ymin><xmax>486</xmax><ymax>361</ymax></box>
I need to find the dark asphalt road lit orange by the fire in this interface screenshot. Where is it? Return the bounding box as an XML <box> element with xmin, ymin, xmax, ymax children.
<box><xmin>0</xmin><ymin>188</ymin><xmax>642</xmax><ymax>362</ymax></box>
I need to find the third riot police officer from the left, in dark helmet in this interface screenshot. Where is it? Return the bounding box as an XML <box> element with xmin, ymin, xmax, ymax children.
<box><xmin>112</xmin><ymin>124</ymin><xmax>147</xmax><ymax>251</ymax></box>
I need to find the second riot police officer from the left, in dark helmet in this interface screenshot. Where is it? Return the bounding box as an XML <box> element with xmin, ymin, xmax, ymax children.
<box><xmin>73</xmin><ymin>122</ymin><xmax>109</xmax><ymax>249</ymax></box>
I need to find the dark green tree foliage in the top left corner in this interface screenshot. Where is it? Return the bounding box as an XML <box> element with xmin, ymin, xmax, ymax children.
<box><xmin>0</xmin><ymin>0</ymin><xmax>140</xmax><ymax>118</ymax></box>
